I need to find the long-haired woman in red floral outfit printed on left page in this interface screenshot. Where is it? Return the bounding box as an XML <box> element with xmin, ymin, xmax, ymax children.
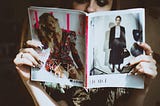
<box><xmin>35</xmin><ymin>13</ymin><xmax>84</xmax><ymax>80</ymax></box>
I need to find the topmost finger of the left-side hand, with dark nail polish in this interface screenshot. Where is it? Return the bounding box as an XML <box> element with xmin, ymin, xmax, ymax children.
<box><xmin>26</xmin><ymin>40</ymin><xmax>43</xmax><ymax>48</ymax></box>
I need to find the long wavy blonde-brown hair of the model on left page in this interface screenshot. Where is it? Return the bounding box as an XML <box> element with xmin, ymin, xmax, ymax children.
<box><xmin>36</xmin><ymin>13</ymin><xmax>62</xmax><ymax>48</ymax></box>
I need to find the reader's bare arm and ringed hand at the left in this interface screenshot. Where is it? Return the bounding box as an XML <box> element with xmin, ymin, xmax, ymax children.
<box><xmin>14</xmin><ymin>41</ymin><xmax>58</xmax><ymax>106</ymax></box>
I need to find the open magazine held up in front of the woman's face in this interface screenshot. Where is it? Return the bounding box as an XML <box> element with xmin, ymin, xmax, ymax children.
<box><xmin>28</xmin><ymin>6</ymin><xmax>145</xmax><ymax>89</ymax></box>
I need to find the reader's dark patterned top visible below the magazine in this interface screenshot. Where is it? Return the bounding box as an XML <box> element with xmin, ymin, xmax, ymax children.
<box><xmin>42</xmin><ymin>83</ymin><xmax>129</xmax><ymax>106</ymax></box>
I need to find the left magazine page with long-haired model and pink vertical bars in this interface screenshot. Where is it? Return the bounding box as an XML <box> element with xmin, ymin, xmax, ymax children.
<box><xmin>28</xmin><ymin>6</ymin><xmax>86</xmax><ymax>86</ymax></box>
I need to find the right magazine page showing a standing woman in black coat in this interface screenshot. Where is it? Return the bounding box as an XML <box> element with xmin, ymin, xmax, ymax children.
<box><xmin>85</xmin><ymin>8</ymin><xmax>145</xmax><ymax>89</ymax></box>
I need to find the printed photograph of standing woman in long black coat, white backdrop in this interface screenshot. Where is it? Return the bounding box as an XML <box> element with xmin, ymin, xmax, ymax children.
<box><xmin>90</xmin><ymin>10</ymin><xmax>144</xmax><ymax>75</ymax></box>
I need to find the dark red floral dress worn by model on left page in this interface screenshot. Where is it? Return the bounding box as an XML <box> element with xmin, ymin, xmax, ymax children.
<box><xmin>46</xmin><ymin>30</ymin><xmax>83</xmax><ymax>70</ymax></box>
